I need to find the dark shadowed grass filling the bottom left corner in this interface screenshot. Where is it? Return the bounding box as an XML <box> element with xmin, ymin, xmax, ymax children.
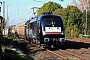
<box><xmin>1</xmin><ymin>49</ymin><xmax>34</xmax><ymax>60</ymax></box>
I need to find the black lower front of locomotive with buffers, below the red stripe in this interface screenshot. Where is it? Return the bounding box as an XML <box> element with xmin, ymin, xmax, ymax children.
<box><xmin>41</xmin><ymin>38</ymin><xmax>65</xmax><ymax>48</ymax></box>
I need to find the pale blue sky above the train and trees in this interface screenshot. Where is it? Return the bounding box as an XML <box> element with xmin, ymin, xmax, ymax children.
<box><xmin>1</xmin><ymin>0</ymin><xmax>72</xmax><ymax>25</ymax></box>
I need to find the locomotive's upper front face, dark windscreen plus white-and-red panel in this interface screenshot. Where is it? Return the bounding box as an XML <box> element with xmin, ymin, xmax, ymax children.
<box><xmin>41</xmin><ymin>16</ymin><xmax>63</xmax><ymax>34</ymax></box>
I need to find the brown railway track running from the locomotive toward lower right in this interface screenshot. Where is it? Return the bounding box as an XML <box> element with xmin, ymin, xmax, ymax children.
<box><xmin>31</xmin><ymin>42</ymin><xmax>88</xmax><ymax>60</ymax></box>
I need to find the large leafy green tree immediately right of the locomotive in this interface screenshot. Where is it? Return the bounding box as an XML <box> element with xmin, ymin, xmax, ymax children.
<box><xmin>53</xmin><ymin>6</ymin><xmax>83</xmax><ymax>37</ymax></box>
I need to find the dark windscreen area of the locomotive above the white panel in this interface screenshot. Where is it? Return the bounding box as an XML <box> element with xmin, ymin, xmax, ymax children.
<box><xmin>42</xmin><ymin>16</ymin><xmax>63</xmax><ymax>31</ymax></box>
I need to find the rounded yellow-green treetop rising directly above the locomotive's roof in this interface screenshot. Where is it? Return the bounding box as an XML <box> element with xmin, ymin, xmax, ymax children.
<box><xmin>37</xmin><ymin>1</ymin><xmax>62</xmax><ymax>16</ymax></box>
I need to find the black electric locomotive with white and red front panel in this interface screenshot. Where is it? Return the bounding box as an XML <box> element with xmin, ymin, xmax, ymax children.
<box><xmin>25</xmin><ymin>14</ymin><xmax>65</xmax><ymax>48</ymax></box>
